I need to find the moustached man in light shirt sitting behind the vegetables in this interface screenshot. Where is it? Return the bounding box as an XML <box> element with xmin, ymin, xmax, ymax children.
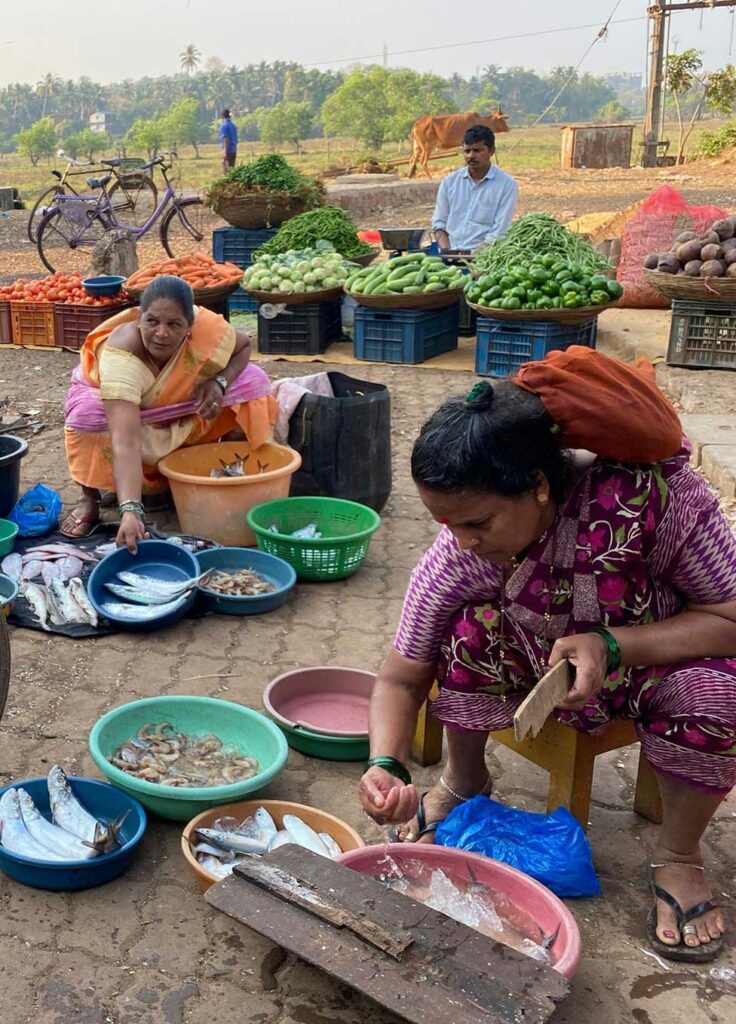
<box><xmin>432</xmin><ymin>125</ymin><xmax>519</xmax><ymax>252</ymax></box>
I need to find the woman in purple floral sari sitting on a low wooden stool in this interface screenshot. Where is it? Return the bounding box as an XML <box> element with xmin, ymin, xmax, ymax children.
<box><xmin>360</xmin><ymin>381</ymin><xmax>736</xmax><ymax>961</ymax></box>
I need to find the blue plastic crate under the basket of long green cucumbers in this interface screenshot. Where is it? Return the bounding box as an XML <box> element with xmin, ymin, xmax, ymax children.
<box><xmin>354</xmin><ymin>302</ymin><xmax>460</xmax><ymax>366</ymax></box>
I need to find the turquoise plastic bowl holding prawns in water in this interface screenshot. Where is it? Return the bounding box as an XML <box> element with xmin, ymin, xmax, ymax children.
<box><xmin>89</xmin><ymin>694</ymin><xmax>289</xmax><ymax>821</ymax></box>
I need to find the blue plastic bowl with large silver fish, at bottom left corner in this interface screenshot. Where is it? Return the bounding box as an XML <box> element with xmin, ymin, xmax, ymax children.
<box><xmin>0</xmin><ymin>775</ymin><xmax>146</xmax><ymax>892</ymax></box>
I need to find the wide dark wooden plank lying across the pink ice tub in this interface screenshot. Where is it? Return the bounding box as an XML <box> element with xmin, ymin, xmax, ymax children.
<box><xmin>205</xmin><ymin>847</ymin><xmax>569</xmax><ymax>1024</ymax></box>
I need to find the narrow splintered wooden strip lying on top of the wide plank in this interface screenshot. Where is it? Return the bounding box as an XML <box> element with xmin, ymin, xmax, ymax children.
<box><xmin>235</xmin><ymin>857</ymin><xmax>414</xmax><ymax>959</ymax></box>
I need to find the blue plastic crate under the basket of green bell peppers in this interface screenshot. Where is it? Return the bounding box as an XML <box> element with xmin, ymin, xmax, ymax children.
<box><xmin>475</xmin><ymin>316</ymin><xmax>598</xmax><ymax>377</ymax></box>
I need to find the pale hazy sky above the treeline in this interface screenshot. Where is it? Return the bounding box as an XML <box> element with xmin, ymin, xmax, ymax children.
<box><xmin>0</xmin><ymin>0</ymin><xmax>736</xmax><ymax>85</ymax></box>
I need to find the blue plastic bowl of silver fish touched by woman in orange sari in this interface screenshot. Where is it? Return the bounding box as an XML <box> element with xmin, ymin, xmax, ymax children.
<box><xmin>87</xmin><ymin>541</ymin><xmax>200</xmax><ymax>633</ymax></box>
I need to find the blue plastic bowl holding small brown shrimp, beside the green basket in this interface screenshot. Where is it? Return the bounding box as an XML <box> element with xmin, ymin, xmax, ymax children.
<box><xmin>194</xmin><ymin>548</ymin><xmax>297</xmax><ymax>615</ymax></box>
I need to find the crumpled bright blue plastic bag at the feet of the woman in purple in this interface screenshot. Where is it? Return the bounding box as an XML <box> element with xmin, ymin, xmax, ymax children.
<box><xmin>435</xmin><ymin>797</ymin><xmax>601</xmax><ymax>896</ymax></box>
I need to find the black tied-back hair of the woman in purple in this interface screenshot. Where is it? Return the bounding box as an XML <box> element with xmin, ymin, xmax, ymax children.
<box><xmin>412</xmin><ymin>380</ymin><xmax>570</xmax><ymax>504</ymax></box>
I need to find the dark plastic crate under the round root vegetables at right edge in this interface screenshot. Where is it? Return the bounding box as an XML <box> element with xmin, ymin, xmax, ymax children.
<box><xmin>666</xmin><ymin>299</ymin><xmax>736</xmax><ymax>370</ymax></box>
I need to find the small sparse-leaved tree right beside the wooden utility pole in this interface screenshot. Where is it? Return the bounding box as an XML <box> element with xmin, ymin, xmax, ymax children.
<box><xmin>664</xmin><ymin>49</ymin><xmax>736</xmax><ymax>164</ymax></box>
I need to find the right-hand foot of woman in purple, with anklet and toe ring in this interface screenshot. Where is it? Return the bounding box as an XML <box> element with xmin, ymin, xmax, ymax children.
<box><xmin>652</xmin><ymin>846</ymin><xmax>726</xmax><ymax>948</ymax></box>
